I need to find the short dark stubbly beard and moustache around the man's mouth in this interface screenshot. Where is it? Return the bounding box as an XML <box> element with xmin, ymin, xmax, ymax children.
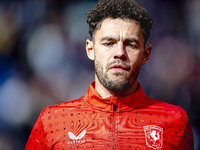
<box><xmin>94</xmin><ymin>55</ymin><xmax>141</xmax><ymax>92</ymax></box>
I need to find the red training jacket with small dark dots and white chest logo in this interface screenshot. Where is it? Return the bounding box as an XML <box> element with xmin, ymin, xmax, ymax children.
<box><xmin>25</xmin><ymin>82</ymin><xmax>194</xmax><ymax>150</ymax></box>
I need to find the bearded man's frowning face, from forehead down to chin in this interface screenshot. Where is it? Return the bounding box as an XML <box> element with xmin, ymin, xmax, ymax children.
<box><xmin>86</xmin><ymin>18</ymin><xmax>150</xmax><ymax>93</ymax></box>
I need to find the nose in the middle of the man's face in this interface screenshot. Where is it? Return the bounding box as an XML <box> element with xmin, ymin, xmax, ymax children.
<box><xmin>113</xmin><ymin>42</ymin><xmax>127</xmax><ymax>60</ymax></box>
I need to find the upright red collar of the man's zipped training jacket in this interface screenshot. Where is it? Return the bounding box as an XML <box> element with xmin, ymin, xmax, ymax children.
<box><xmin>85</xmin><ymin>81</ymin><xmax>147</xmax><ymax>111</ymax></box>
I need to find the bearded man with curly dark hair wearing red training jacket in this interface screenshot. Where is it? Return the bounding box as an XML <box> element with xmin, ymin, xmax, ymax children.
<box><xmin>25</xmin><ymin>0</ymin><xmax>193</xmax><ymax>150</ymax></box>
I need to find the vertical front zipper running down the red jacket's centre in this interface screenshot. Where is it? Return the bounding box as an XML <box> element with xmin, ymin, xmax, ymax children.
<box><xmin>111</xmin><ymin>98</ymin><xmax>117</xmax><ymax>150</ymax></box>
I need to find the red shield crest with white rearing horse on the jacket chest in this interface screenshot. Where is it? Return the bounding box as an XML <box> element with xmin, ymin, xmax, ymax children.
<box><xmin>143</xmin><ymin>125</ymin><xmax>163</xmax><ymax>149</ymax></box>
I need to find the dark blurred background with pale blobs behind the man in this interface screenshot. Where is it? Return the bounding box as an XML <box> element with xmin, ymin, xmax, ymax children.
<box><xmin>0</xmin><ymin>0</ymin><xmax>200</xmax><ymax>150</ymax></box>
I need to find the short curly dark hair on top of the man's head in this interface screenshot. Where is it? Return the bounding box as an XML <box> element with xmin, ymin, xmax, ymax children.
<box><xmin>87</xmin><ymin>0</ymin><xmax>153</xmax><ymax>43</ymax></box>
